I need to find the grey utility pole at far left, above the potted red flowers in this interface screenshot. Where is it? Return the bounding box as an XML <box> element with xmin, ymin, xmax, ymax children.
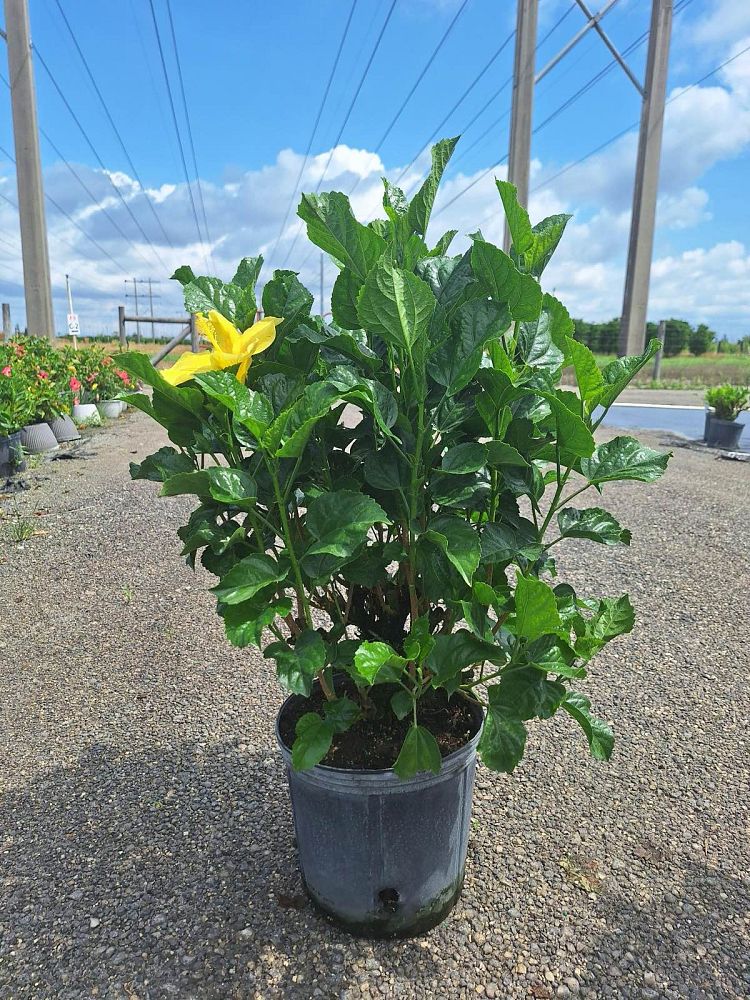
<box><xmin>5</xmin><ymin>0</ymin><xmax>55</xmax><ymax>339</ymax></box>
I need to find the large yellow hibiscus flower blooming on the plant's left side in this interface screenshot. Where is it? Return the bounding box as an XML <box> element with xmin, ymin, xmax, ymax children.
<box><xmin>161</xmin><ymin>309</ymin><xmax>282</xmax><ymax>385</ymax></box>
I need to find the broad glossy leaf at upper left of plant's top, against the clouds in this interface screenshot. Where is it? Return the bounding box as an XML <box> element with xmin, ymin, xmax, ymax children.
<box><xmin>297</xmin><ymin>191</ymin><xmax>385</xmax><ymax>281</ymax></box>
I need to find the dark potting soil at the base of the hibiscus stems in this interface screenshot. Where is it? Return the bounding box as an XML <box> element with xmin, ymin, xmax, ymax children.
<box><xmin>279</xmin><ymin>677</ymin><xmax>477</xmax><ymax>770</ymax></box>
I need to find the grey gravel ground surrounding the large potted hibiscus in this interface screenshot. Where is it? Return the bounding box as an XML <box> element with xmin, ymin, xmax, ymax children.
<box><xmin>0</xmin><ymin>414</ymin><xmax>750</xmax><ymax>1000</ymax></box>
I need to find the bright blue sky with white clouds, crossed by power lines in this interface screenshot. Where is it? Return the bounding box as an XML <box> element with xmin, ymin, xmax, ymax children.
<box><xmin>0</xmin><ymin>0</ymin><xmax>750</xmax><ymax>338</ymax></box>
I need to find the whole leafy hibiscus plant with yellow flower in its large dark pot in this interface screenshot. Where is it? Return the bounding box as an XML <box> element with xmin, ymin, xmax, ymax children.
<box><xmin>120</xmin><ymin>139</ymin><xmax>669</xmax><ymax>936</ymax></box>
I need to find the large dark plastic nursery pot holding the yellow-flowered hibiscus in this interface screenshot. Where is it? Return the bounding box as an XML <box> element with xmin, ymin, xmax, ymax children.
<box><xmin>276</xmin><ymin>696</ymin><xmax>482</xmax><ymax>937</ymax></box>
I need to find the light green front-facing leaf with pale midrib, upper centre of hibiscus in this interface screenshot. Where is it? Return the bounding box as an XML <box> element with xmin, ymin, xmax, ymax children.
<box><xmin>357</xmin><ymin>263</ymin><xmax>435</xmax><ymax>354</ymax></box>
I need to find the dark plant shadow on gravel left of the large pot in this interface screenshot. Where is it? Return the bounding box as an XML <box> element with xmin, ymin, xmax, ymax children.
<box><xmin>0</xmin><ymin>743</ymin><xmax>440</xmax><ymax>1000</ymax></box>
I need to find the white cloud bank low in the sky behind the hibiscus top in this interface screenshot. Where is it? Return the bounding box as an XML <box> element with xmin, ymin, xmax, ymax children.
<box><xmin>0</xmin><ymin>35</ymin><xmax>750</xmax><ymax>335</ymax></box>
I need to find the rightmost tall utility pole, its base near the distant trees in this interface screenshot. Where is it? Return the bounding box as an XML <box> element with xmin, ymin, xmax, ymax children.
<box><xmin>619</xmin><ymin>0</ymin><xmax>673</xmax><ymax>355</ymax></box>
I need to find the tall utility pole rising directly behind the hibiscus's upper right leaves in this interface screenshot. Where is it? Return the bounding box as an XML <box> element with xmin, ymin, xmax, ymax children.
<box><xmin>503</xmin><ymin>0</ymin><xmax>539</xmax><ymax>253</ymax></box>
